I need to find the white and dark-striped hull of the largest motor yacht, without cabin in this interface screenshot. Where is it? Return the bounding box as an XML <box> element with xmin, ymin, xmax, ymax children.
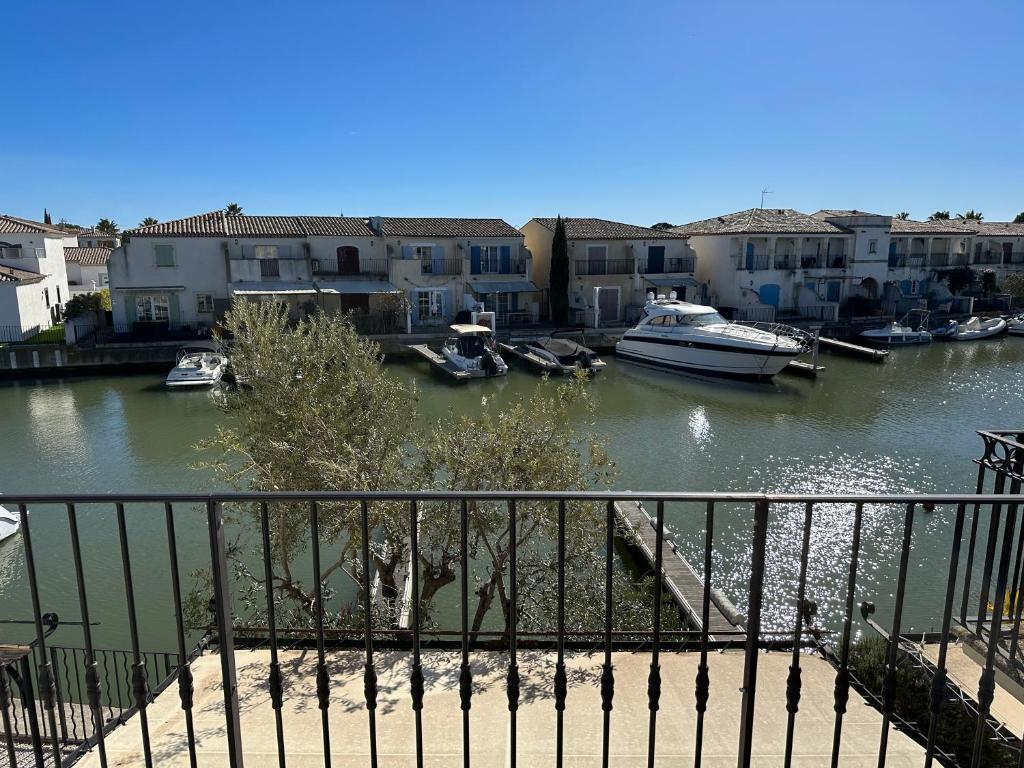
<box><xmin>615</xmin><ymin>336</ymin><xmax>800</xmax><ymax>381</ymax></box>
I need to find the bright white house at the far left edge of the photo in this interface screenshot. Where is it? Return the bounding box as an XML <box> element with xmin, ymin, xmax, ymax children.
<box><xmin>0</xmin><ymin>215</ymin><xmax>69</xmax><ymax>341</ymax></box>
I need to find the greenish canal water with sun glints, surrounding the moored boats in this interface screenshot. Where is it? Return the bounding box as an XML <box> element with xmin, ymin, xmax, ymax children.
<box><xmin>0</xmin><ymin>338</ymin><xmax>1024</xmax><ymax>650</ymax></box>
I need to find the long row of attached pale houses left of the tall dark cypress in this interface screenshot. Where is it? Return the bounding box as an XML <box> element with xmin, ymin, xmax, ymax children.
<box><xmin>109</xmin><ymin>211</ymin><xmax>538</xmax><ymax>332</ymax></box>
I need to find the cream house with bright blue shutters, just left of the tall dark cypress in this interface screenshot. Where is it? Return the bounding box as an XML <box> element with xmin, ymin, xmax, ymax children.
<box><xmin>368</xmin><ymin>216</ymin><xmax>532</xmax><ymax>328</ymax></box>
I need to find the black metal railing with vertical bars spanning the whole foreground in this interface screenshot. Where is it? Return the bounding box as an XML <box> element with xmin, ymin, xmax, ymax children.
<box><xmin>6</xmin><ymin>431</ymin><xmax>1024</xmax><ymax>766</ymax></box>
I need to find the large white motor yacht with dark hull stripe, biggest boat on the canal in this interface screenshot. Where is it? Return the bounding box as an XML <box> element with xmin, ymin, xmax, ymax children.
<box><xmin>615</xmin><ymin>295</ymin><xmax>805</xmax><ymax>380</ymax></box>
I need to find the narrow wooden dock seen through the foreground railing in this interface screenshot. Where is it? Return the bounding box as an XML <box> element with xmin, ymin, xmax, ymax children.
<box><xmin>615</xmin><ymin>502</ymin><xmax>745</xmax><ymax>640</ymax></box>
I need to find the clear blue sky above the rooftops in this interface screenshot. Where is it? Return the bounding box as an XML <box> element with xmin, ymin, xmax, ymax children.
<box><xmin>0</xmin><ymin>0</ymin><xmax>1024</xmax><ymax>226</ymax></box>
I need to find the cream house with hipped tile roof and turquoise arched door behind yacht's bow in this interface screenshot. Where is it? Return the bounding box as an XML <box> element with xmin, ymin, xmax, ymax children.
<box><xmin>673</xmin><ymin>208</ymin><xmax>876</xmax><ymax>321</ymax></box>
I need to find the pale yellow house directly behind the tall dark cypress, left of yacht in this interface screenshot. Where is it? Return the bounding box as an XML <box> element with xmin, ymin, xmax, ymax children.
<box><xmin>522</xmin><ymin>217</ymin><xmax>700</xmax><ymax>326</ymax></box>
